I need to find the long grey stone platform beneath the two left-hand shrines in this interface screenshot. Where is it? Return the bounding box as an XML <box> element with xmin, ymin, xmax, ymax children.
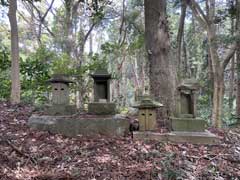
<box><xmin>28</xmin><ymin>115</ymin><xmax>129</xmax><ymax>137</ymax></box>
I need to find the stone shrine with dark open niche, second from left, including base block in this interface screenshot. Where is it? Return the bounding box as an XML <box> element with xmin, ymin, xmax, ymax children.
<box><xmin>88</xmin><ymin>69</ymin><xmax>116</xmax><ymax>115</ymax></box>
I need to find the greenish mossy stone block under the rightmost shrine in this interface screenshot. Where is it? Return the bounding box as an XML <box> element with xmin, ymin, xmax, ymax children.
<box><xmin>171</xmin><ymin>117</ymin><xmax>206</xmax><ymax>132</ymax></box>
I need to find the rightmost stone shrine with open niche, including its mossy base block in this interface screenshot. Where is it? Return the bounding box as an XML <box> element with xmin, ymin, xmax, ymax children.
<box><xmin>171</xmin><ymin>79</ymin><xmax>206</xmax><ymax>132</ymax></box>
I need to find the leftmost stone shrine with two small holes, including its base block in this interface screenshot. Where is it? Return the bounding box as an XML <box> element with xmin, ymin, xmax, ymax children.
<box><xmin>46</xmin><ymin>74</ymin><xmax>76</xmax><ymax>115</ymax></box>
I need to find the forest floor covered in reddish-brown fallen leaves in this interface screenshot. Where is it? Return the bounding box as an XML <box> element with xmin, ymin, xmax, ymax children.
<box><xmin>0</xmin><ymin>102</ymin><xmax>240</xmax><ymax>180</ymax></box>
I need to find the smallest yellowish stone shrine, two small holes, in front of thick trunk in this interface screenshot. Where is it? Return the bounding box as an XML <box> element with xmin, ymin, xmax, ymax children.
<box><xmin>133</xmin><ymin>95</ymin><xmax>163</xmax><ymax>131</ymax></box>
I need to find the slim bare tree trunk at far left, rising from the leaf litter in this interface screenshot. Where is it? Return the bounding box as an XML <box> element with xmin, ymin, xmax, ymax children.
<box><xmin>8</xmin><ymin>0</ymin><xmax>21</xmax><ymax>104</ymax></box>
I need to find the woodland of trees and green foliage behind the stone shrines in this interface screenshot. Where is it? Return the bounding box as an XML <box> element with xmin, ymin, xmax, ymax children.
<box><xmin>0</xmin><ymin>0</ymin><xmax>240</xmax><ymax>127</ymax></box>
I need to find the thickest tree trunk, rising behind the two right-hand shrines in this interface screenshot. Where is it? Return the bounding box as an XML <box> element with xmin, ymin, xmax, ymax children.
<box><xmin>144</xmin><ymin>0</ymin><xmax>174</xmax><ymax>125</ymax></box>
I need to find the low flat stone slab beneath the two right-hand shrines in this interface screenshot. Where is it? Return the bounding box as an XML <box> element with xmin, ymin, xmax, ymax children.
<box><xmin>133</xmin><ymin>131</ymin><xmax>220</xmax><ymax>144</ymax></box>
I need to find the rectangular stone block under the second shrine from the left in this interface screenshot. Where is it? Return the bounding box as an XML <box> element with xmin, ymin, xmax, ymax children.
<box><xmin>88</xmin><ymin>102</ymin><xmax>116</xmax><ymax>115</ymax></box>
